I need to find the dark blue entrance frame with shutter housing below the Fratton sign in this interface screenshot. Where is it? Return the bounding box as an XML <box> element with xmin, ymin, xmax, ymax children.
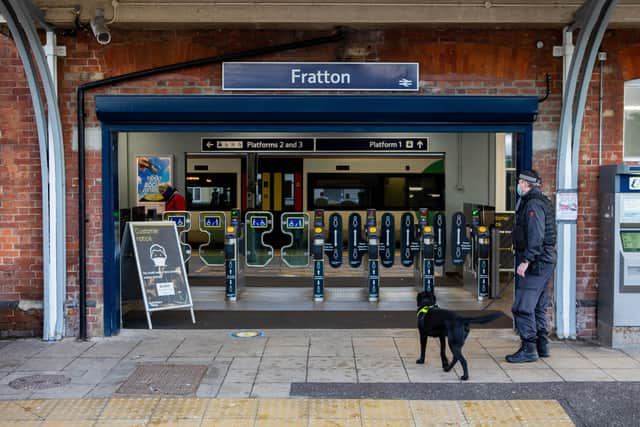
<box><xmin>96</xmin><ymin>95</ymin><xmax>538</xmax><ymax>336</ymax></box>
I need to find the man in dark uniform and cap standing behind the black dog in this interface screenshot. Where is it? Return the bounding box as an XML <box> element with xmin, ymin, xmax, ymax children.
<box><xmin>506</xmin><ymin>170</ymin><xmax>557</xmax><ymax>363</ymax></box>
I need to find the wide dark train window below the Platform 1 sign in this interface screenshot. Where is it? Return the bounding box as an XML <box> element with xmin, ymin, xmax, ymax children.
<box><xmin>307</xmin><ymin>174</ymin><xmax>444</xmax><ymax>211</ymax></box>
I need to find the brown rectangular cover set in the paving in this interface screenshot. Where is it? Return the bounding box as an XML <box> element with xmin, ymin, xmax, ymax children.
<box><xmin>116</xmin><ymin>363</ymin><xmax>207</xmax><ymax>396</ymax></box>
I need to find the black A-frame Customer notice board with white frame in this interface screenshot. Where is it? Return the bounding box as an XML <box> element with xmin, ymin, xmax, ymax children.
<box><xmin>121</xmin><ymin>221</ymin><xmax>196</xmax><ymax>329</ymax></box>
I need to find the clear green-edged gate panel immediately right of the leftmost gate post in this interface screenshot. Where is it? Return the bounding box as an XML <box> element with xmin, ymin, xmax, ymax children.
<box><xmin>244</xmin><ymin>211</ymin><xmax>273</xmax><ymax>267</ymax></box>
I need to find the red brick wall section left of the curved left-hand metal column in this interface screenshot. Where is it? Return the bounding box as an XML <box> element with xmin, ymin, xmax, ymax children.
<box><xmin>0</xmin><ymin>35</ymin><xmax>42</xmax><ymax>337</ymax></box>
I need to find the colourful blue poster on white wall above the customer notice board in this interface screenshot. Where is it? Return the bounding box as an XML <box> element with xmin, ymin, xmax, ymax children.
<box><xmin>136</xmin><ymin>155</ymin><xmax>173</xmax><ymax>207</ymax></box>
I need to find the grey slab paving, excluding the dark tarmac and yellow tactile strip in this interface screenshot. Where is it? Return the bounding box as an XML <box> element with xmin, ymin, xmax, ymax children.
<box><xmin>0</xmin><ymin>329</ymin><xmax>640</xmax><ymax>399</ymax></box>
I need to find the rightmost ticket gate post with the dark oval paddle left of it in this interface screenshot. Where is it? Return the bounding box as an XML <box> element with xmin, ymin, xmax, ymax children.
<box><xmin>451</xmin><ymin>212</ymin><xmax>491</xmax><ymax>301</ymax></box>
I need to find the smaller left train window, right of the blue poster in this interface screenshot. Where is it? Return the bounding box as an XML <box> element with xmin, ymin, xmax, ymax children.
<box><xmin>186</xmin><ymin>173</ymin><xmax>238</xmax><ymax>211</ymax></box>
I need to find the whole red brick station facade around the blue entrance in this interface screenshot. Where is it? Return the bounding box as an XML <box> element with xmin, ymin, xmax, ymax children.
<box><xmin>0</xmin><ymin>29</ymin><xmax>640</xmax><ymax>337</ymax></box>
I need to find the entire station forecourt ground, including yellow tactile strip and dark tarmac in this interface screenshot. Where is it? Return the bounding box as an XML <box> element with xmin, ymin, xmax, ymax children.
<box><xmin>0</xmin><ymin>329</ymin><xmax>640</xmax><ymax>427</ymax></box>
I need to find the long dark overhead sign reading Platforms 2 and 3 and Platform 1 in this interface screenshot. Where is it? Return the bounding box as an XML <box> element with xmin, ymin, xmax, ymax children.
<box><xmin>201</xmin><ymin>137</ymin><xmax>429</xmax><ymax>153</ymax></box>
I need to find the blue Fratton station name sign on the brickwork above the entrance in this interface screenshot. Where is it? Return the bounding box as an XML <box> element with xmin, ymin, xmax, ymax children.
<box><xmin>222</xmin><ymin>62</ymin><xmax>419</xmax><ymax>92</ymax></box>
